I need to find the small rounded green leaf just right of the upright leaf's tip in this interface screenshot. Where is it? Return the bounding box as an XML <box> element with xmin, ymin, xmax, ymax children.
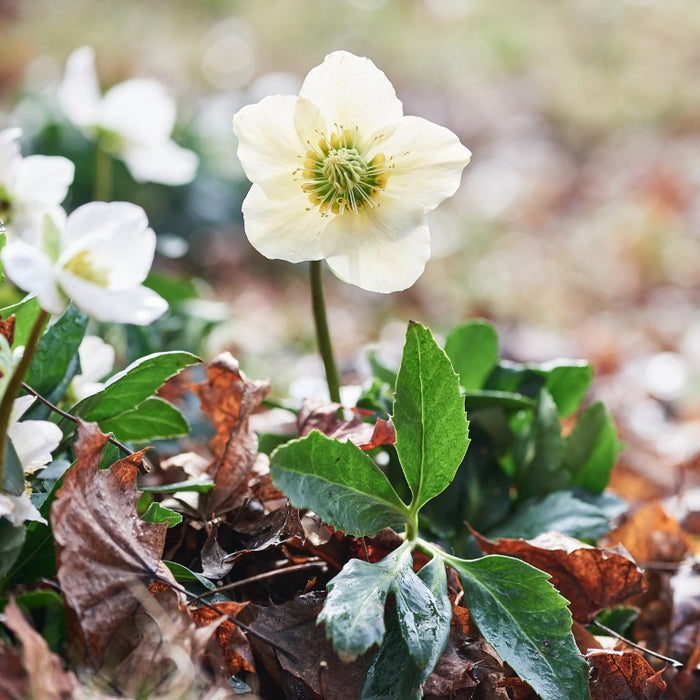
<box><xmin>445</xmin><ymin>320</ymin><xmax>498</xmax><ymax>392</ymax></box>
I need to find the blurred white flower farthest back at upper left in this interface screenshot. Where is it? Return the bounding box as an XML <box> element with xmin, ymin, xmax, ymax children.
<box><xmin>58</xmin><ymin>46</ymin><xmax>198</xmax><ymax>185</ymax></box>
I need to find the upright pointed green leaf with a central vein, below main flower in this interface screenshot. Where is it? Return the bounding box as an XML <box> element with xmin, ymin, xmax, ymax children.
<box><xmin>394</xmin><ymin>322</ymin><xmax>469</xmax><ymax>513</ymax></box>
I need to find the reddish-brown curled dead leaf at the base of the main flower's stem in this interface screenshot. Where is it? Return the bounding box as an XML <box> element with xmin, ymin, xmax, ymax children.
<box><xmin>297</xmin><ymin>399</ymin><xmax>396</xmax><ymax>450</ymax></box>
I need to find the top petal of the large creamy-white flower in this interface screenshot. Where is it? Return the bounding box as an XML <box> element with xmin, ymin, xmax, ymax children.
<box><xmin>299</xmin><ymin>51</ymin><xmax>403</xmax><ymax>142</ymax></box>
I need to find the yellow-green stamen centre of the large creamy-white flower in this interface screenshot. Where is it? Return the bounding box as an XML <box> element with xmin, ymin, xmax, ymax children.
<box><xmin>297</xmin><ymin>129</ymin><xmax>392</xmax><ymax>214</ymax></box>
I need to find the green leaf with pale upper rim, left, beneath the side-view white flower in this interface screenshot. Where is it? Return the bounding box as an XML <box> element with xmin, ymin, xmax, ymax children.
<box><xmin>71</xmin><ymin>351</ymin><xmax>201</xmax><ymax>423</ymax></box>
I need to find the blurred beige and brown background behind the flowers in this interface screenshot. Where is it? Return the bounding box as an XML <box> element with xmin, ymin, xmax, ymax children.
<box><xmin>0</xmin><ymin>0</ymin><xmax>700</xmax><ymax>492</ymax></box>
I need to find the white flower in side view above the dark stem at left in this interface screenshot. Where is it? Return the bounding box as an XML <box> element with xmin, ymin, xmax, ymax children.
<box><xmin>2</xmin><ymin>202</ymin><xmax>168</xmax><ymax>325</ymax></box>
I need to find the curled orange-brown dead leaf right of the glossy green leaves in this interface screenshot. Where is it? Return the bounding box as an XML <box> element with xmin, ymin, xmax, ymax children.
<box><xmin>472</xmin><ymin>531</ymin><xmax>646</xmax><ymax>622</ymax></box>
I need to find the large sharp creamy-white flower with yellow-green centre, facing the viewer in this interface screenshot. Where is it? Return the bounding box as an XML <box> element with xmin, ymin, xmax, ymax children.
<box><xmin>233</xmin><ymin>51</ymin><xmax>471</xmax><ymax>292</ymax></box>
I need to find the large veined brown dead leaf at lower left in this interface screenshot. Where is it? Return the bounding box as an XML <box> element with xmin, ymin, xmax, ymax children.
<box><xmin>50</xmin><ymin>422</ymin><xmax>167</xmax><ymax>662</ymax></box>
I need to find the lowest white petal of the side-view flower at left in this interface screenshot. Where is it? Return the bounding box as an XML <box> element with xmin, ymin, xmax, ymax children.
<box><xmin>54</xmin><ymin>270</ymin><xmax>168</xmax><ymax>326</ymax></box>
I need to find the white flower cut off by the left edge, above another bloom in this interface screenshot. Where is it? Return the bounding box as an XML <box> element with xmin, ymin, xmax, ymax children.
<box><xmin>0</xmin><ymin>128</ymin><xmax>75</xmax><ymax>243</ymax></box>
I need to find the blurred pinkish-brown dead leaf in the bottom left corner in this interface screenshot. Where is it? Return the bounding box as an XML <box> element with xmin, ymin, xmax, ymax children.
<box><xmin>0</xmin><ymin>598</ymin><xmax>79</xmax><ymax>700</ymax></box>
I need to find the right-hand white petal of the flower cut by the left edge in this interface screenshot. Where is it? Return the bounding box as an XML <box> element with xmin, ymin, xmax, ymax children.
<box><xmin>15</xmin><ymin>156</ymin><xmax>75</xmax><ymax>206</ymax></box>
